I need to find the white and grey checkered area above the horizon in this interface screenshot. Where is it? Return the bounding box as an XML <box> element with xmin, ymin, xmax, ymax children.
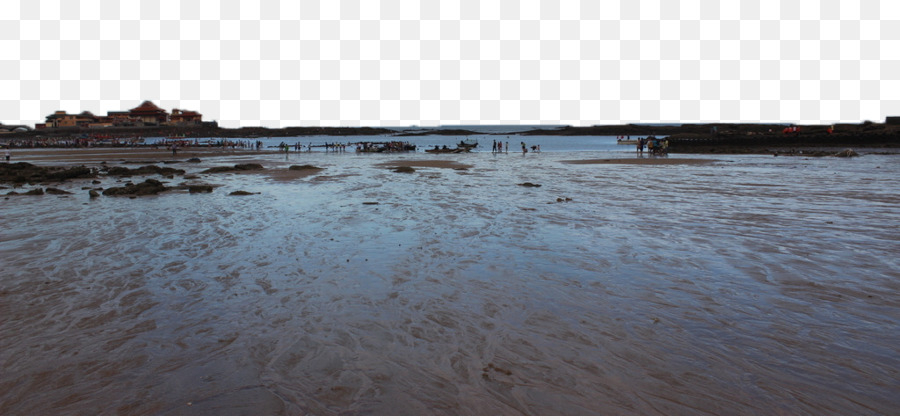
<box><xmin>0</xmin><ymin>0</ymin><xmax>900</xmax><ymax>127</ymax></box>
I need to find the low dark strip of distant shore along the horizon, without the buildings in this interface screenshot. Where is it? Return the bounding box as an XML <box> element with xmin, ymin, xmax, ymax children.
<box><xmin>0</xmin><ymin>121</ymin><xmax>900</xmax><ymax>154</ymax></box>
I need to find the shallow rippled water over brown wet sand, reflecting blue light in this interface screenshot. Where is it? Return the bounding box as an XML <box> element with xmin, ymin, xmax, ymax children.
<box><xmin>0</xmin><ymin>152</ymin><xmax>900</xmax><ymax>415</ymax></box>
